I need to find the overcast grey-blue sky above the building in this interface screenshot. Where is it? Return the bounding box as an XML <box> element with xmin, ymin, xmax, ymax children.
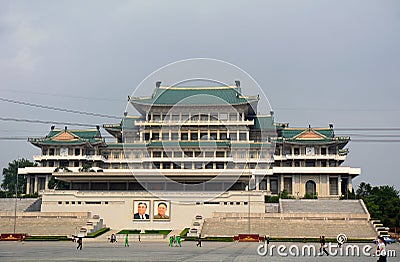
<box><xmin>0</xmin><ymin>0</ymin><xmax>400</xmax><ymax>189</ymax></box>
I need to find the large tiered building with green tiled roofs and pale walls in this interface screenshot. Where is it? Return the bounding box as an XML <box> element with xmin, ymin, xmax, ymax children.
<box><xmin>19</xmin><ymin>81</ymin><xmax>361</xmax><ymax>228</ymax></box>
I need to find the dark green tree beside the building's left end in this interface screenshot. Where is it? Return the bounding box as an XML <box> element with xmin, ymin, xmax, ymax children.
<box><xmin>1</xmin><ymin>158</ymin><xmax>37</xmax><ymax>195</ymax></box>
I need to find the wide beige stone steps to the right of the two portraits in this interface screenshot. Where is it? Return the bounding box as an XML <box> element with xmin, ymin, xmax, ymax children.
<box><xmin>201</xmin><ymin>199</ymin><xmax>378</xmax><ymax>239</ymax></box>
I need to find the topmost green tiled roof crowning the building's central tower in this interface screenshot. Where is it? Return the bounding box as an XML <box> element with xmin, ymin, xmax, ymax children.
<box><xmin>131</xmin><ymin>86</ymin><xmax>258</xmax><ymax>105</ymax></box>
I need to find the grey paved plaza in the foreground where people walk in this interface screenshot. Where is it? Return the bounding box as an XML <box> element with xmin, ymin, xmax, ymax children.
<box><xmin>0</xmin><ymin>241</ymin><xmax>400</xmax><ymax>262</ymax></box>
